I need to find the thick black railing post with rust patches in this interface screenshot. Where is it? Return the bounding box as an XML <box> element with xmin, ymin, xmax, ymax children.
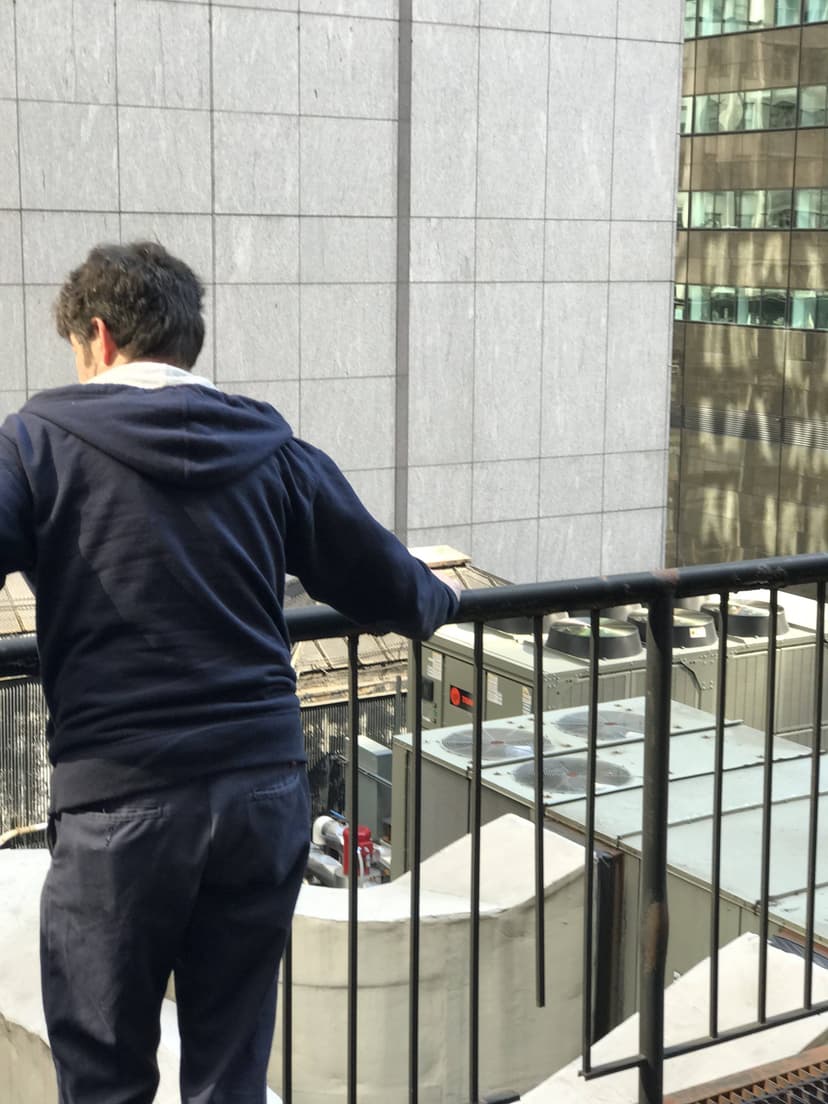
<box><xmin>638</xmin><ymin>590</ymin><xmax>672</xmax><ymax>1104</ymax></box>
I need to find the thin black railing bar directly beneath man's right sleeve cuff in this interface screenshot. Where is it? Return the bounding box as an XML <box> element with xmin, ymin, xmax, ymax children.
<box><xmin>408</xmin><ymin>640</ymin><xmax>423</xmax><ymax>1104</ymax></box>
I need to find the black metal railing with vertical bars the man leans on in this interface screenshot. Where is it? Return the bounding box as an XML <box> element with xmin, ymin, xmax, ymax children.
<box><xmin>0</xmin><ymin>553</ymin><xmax>828</xmax><ymax>1104</ymax></box>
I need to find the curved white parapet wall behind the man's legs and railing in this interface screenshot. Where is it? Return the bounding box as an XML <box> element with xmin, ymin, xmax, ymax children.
<box><xmin>0</xmin><ymin>816</ymin><xmax>584</xmax><ymax>1104</ymax></box>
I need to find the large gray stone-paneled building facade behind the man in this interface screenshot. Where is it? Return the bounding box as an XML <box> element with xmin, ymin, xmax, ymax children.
<box><xmin>0</xmin><ymin>0</ymin><xmax>683</xmax><ymax>581</ymax></box>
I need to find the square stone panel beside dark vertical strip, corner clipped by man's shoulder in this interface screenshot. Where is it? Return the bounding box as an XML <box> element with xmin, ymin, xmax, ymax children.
<box><xmin>300</xmin><ymin>379</ymin><xmax>394</xmax><ymax>470</ymax></box>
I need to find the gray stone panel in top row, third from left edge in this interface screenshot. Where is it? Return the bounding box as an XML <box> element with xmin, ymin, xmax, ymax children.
<box><xmin>117</xmin><ymin>0</ymin><xmax>210</xmax><ymax>108</ymax></box>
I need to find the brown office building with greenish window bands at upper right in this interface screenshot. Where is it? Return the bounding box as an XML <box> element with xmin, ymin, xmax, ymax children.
<box><xmin>667</xmin><ymin>0</ymin><xmax>828</xmax><ymax>564</ymax></box>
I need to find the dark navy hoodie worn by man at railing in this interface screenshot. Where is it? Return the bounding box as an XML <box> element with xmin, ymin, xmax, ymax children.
<box><xmin>0</xmin><ymin>383</ymin><xmax>457</xmax><ymax>810</ymax></box>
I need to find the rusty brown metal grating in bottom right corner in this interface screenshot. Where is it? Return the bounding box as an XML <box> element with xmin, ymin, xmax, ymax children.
<box><xmin>665</xmin><ymin>1047</ymin><xmax>828</xmax><ymax>1104</ymax></box>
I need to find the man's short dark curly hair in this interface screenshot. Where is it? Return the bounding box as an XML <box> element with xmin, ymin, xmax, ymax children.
<box><xmin>55</xmin><ymin>242</ymin><xmax>204</xmax><ymax>369</ymax></box>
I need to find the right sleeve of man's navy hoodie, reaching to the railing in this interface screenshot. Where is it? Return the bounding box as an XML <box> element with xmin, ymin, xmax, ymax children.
<box><xmin>279</xmin><ymin>439</ymin><xmax>458</xmax><ymax>640</ymax></box>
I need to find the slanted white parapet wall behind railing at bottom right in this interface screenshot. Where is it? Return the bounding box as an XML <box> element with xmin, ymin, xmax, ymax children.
<box><xmin>522</xmin><ymin>934</ymin><xmax>828</xmax><ymax>1104</ymax></box>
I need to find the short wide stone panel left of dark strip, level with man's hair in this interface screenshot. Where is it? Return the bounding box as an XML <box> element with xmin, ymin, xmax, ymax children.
<box><xmin>299</xmin><ymin>217</ymin><xmax>396</xmax><ymax>284</ymax></box>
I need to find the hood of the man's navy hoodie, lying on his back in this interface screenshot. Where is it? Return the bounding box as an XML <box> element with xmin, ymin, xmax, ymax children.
<box><xmin>20</xmin><ymin>383</ymin><xmax>291</xmax><ymax>487</ymax></box>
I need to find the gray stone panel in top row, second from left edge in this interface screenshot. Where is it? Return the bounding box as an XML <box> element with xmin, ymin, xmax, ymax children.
<box><xmin>17</xmin><ymin>0</ymin><xmax>115</xmax><ymax>104</ymax></box>
